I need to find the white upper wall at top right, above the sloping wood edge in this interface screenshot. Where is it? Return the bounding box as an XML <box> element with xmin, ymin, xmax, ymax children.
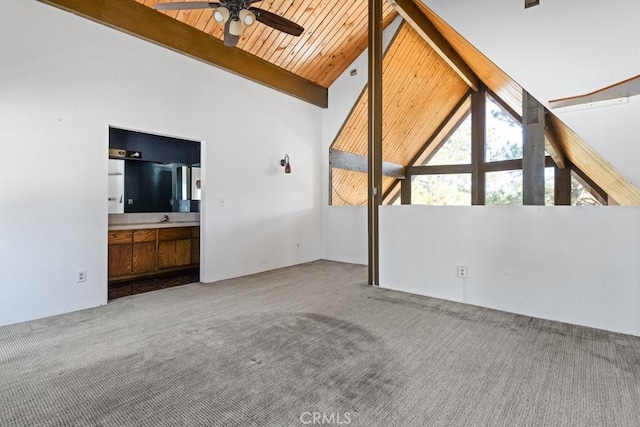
<box><xmin>423</xmin><ymin>0</ymin><xmax>640</xmax><ymax>187</ymax></box>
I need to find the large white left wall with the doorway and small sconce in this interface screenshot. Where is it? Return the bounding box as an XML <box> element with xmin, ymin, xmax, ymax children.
<box><xmin>0</xmin><ymin>0</ymin><xmax>322</xmax><ymax>324</ymax></box>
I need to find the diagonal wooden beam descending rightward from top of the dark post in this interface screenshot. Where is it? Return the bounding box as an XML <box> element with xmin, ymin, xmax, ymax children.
<box><xmin>389</xmin><ymin>0</ymin><xmax>480</xmax><ymax>91</ymax></box>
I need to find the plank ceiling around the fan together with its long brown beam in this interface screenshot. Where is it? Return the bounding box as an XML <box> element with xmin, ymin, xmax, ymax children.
<box><xmin>39</xmin><ymin>0</ymin><xmax>397</xmax><ymax>108</ymax></box>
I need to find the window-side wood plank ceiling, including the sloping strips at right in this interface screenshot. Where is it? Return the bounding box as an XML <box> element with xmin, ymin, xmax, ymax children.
<box><xmin>331</xmin><ymin>0</ymin><xmax>640</xmax><ymax>205</ymax></box>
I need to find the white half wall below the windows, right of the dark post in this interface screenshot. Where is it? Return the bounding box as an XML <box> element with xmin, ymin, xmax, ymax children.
<box><xmin>380</xmin><ymin>206</ymin><xmax>640</xmax><ymax>335</ymax></box>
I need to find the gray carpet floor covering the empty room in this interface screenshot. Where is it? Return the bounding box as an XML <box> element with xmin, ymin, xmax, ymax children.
<box><xmin>0</xmin><ymin>261</ymin><xmax>640</xmax><ymax>427</ymax></box>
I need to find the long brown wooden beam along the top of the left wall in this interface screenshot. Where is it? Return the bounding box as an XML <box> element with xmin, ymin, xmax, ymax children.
<box><xmin>39</xmin><ymin>0</ymin><xmax>328</xmax><ymax>108</ymax></box>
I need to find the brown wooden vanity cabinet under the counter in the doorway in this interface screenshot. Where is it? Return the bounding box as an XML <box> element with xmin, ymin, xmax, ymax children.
<box><xmin>108</xmin><ymin>227</ymin><xmax>200</xmax><ymax>280</ymax></box>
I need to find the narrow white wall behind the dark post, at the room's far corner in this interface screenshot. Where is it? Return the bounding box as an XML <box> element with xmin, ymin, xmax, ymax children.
<box><xmin>322</xmin><ymin>17</ymin><xmax>402</xmax><ymax>264</ymax></box>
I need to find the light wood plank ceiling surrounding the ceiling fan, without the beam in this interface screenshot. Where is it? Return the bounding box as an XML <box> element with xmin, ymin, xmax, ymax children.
<box><xmin>142</xmin><ymin>0</ymin><xmax>397</xmax><ymax>87</ymax></box>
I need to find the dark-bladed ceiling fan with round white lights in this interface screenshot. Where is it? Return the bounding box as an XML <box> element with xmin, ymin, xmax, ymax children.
<box><xmin>154</xmin><ymin>0</ymin><xmax>304</xmax><ymax>46</ymax></box>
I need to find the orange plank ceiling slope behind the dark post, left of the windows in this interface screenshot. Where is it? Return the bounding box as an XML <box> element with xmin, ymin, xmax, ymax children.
<box><xmin>332</xmin><ymin>24</ymin><xmax>469</xmax><ymax>205</ymax></box>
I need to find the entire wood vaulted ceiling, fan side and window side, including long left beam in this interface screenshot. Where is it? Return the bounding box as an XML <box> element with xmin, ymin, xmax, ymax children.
<box><xmin>40</xmin><ymin>0</ymin><xmax>640</xmax><ymax>205</ymax></box>
